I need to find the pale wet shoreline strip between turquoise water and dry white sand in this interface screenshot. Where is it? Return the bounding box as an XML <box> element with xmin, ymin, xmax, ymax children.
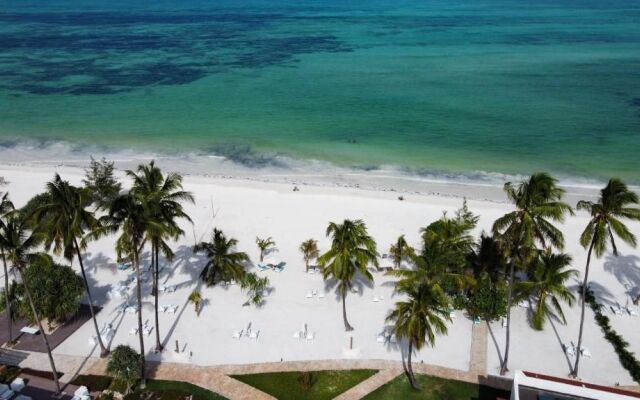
<box><xmin>0</xmin><ymin>142</ymin><xmax>624</xmax><ymax>205</ymax></box>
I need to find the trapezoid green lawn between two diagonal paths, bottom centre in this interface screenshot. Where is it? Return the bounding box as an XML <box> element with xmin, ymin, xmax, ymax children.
<box><xmin>232</xmin><ymin>369</ymin><xmax>378</xmax><ymax>400</ymax></box>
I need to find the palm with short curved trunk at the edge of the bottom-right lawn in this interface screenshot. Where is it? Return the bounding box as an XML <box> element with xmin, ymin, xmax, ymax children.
<box><xmin>386</xmin><ymin>283</ymin><xmax>451</xmax><ymax>390</ymax></box>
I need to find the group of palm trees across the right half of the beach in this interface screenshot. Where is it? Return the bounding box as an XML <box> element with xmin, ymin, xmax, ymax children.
<box><xmin>316</xmin><ymin>173</ymin><xmax>640</xmax><ymax>388</ymax></box>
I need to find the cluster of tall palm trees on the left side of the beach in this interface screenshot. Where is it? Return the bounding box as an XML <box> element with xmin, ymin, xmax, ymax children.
<box><xmin>0</xmin><ymin>161</ymin><xmax>193</xmax><ymax>391</ymax></box>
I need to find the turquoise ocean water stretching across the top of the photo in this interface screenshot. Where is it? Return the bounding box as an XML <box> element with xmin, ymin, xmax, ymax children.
<box><xmin>0</xmin><ymin>0</ymin><xmax>640</xmax><ymax>184</ymax></box>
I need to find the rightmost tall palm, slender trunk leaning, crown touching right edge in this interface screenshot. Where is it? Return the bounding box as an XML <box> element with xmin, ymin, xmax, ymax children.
<box><xmin>571</xmin><ymin>178</ymin><xmax>640</xmax><ymax>377</ymax></box>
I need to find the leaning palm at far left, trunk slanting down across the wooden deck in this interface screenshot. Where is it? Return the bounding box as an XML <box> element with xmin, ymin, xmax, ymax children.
<box><xmin>0</xmin><ymin>214</ymin><xmax>61</xmax><ymax>393</ymax></box>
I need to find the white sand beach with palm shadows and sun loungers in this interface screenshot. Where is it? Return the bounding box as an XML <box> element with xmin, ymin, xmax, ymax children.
<box><xmin>0</xmin><ymin>165</ymin><xmax>640</xmax><ymax>385</ymax></box>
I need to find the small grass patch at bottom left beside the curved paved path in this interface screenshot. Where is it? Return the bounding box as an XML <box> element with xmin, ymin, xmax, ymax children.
<box><xmin>124</xmin><ymin>380</ymin><xmax>226</xmax><ymax>400</ymax></box>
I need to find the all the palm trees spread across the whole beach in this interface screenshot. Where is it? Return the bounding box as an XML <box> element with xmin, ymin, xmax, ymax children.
<box><xmin>0</xmin><ymin>161</ymin><xmax>640</xmax><ymax>389</ymax></box>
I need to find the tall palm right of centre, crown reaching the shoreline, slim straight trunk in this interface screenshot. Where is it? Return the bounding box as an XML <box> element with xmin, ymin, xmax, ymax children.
<box><xmin>492</xmin><ymin>172</ymin><xmax>573</xmax><ymax>375</ymax></box>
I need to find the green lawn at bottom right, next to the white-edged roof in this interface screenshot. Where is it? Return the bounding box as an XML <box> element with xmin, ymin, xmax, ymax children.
<box><xmin>365</xmin><ymin>374</ymin><xmax>509</xmax><ymax>400</ymax></box>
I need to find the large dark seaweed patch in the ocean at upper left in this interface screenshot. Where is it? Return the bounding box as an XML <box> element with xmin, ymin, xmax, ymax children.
<box><xmin>0</xmin><ymin>13</ymin><xmax>351</xmax><ymax>95</ymax></box>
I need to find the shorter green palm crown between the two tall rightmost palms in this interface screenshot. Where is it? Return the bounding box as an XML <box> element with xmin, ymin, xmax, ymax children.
<box><xmin>515</xmin><ymin>249</ymin><xmax>578</xmax><ymax>331</ymax></box>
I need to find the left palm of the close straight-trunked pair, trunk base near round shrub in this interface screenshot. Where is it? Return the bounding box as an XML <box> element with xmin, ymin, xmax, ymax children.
<box><xmin>104</xmin><ymin>192</ymin><xmax>161</xmax><ymax>388</ymax></box>
